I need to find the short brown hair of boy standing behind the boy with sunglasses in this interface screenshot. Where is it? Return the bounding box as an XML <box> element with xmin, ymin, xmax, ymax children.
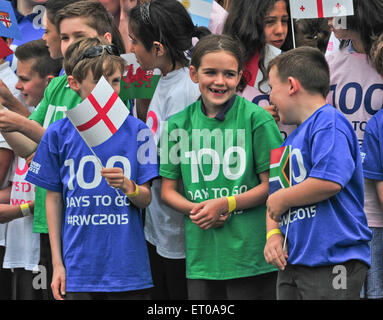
<box><xmin>55</xmin><ymin>0</ymin><xmax>125</xmax><ymax>53</ymax></box>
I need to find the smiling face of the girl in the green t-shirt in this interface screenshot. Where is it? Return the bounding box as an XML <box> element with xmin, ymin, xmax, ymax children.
<box><xmin>190</xmin><ymin>51</ymin><xmax>242</xmax><ymax>112</ymax></box>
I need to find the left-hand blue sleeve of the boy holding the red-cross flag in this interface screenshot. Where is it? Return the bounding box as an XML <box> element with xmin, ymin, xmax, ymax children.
<box><xmin>25</xmin><ymin>128</ymin><xmax>62</xmax><ymax>192</ymax></box>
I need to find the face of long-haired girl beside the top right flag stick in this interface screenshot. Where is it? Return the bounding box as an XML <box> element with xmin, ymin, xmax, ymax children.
<box><xmin>263</xmin><ymin>1</ymin><xmax>289</xmax><ymax>48</ymax></box>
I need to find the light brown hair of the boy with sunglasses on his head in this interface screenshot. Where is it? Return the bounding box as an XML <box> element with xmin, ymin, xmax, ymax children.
<box><xmin>64</xmin><ymin>37</ymin><xmax>125</xmax><ymax>83</ymax></box>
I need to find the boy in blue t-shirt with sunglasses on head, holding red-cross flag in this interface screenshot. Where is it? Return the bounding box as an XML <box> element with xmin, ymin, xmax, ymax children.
<box><xmin>27</xmin><ymin>38</ymin><xmax>158</xmax><ymax>299</ymax></box>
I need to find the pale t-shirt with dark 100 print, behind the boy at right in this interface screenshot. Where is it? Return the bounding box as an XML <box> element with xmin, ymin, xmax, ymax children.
<box><xmin>326</xmin><ymin>45</ymin><xmax>383</xmax><ymax>227</ymax></box>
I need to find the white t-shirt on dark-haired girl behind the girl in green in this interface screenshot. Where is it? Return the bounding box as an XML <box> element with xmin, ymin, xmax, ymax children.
<box><xmin>145</xmin><ymin>68</ymin><xmax>200</xmax><ymax>259</ymax></box>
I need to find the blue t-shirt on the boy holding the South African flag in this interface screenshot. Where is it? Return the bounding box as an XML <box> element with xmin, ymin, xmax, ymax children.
<box><xmin>280</xmin><ymin>104</ymin><xmax>371</xmax><ymax>266</ymax></box>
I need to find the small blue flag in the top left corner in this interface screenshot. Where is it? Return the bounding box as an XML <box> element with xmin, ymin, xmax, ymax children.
<box><xmin>0</xmin><ymin>0</ymin><xmax>23</xmax><ymax>40</ymax></box>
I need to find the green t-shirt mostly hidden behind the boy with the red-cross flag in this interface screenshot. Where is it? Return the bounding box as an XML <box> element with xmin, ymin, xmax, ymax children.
<box><xmin>29</xmin><ymin>75</ymin><xmax>130</xmax><ymax>233</ymax></box>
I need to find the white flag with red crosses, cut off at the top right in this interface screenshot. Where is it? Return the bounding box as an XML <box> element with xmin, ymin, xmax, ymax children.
<box><xmin>290</xmin><ymin>0</ymin><xmax>354</xmax><ymax>19</ymax></box>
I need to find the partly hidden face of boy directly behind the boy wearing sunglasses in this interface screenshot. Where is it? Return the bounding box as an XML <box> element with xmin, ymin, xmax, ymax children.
<box><xmin>60</xmin><ymin>17</ymin><xmax>99</xmax><ymax>56</ymax></box>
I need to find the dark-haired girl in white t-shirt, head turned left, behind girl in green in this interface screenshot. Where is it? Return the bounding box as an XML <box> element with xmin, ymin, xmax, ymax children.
<box><xmin>129</xmin><ymin>0</ymin><xmax>209</xmax><ymax>299</ymax></box>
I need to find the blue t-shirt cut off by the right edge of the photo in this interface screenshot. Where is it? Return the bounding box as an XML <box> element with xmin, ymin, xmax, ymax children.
<box><xmin>362</xmin><ymin>110</ymin><xmax>383</xmax><ymax>180</ymax></box>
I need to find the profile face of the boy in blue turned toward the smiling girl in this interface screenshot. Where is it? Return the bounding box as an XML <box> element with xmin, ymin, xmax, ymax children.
<box><xmin>269</xmin><ymin>66</ymin><xmax>295</xmax><ymax>124</ymax></box>
